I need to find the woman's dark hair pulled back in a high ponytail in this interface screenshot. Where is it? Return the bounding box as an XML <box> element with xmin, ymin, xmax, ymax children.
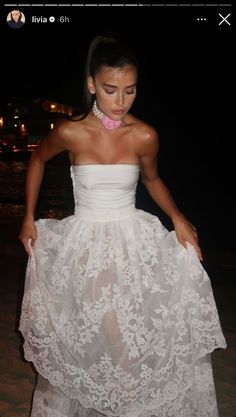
<box><xmin>77</xmin><ymin>36</ymin><xmax>138</xmax><ymax>118</ymax></box>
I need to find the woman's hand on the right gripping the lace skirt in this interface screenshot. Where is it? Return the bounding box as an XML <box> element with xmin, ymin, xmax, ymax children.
<box><xmin>172</xmin><ymin>215</ymin><xmax>203</xmax><ymax>261</ymax></box>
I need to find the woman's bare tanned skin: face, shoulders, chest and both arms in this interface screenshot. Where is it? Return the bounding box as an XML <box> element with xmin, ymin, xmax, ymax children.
<box><xmin>19</xmin><ymin>65</ymin><xmax>203</xmax><ymax>260</ymax></box>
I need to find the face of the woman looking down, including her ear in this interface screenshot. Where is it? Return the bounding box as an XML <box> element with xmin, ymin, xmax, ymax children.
<box><xmin>88</xmin><ymin>65</ymin><xmax>138</xmax><ymax>120</ymax></box>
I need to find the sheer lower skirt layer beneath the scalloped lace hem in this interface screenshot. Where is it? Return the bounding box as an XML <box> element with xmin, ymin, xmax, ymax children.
<box><xmin>31</xmin><ymin>355</ymin><xmax>218</xmax><ymax>417</ymax></box>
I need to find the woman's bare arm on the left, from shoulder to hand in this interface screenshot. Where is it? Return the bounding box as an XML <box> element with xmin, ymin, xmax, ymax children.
<box><xmin>19</xmin><ymin>120</ymin><xmax>66</xmax><ymax>255</ymax></box>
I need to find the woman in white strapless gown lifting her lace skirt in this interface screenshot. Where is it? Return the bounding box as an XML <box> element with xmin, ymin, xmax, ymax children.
<box><xmin>20</xmin><ymin>37</ymin><xmax>225</xmax><ymax>417</ymax></box>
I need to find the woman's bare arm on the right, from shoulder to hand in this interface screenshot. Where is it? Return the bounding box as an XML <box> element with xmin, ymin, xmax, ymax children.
<box><xmin>141</xmin><ymin>128</ymin><xmax>203</xmax><ymax>260</ymax></box>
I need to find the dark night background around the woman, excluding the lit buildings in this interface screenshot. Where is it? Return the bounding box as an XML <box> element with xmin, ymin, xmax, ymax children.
<box><xmin>0</xmin><ymin>2</ymin><xmax>236</xmax><ymax>417</ymax></box>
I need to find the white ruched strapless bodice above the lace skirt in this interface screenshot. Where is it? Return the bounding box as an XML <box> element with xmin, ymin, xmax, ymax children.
<box><xmin>71</xmin><ymin>164</ymin><xmax>140</xmax><ymax>220</ymax></box>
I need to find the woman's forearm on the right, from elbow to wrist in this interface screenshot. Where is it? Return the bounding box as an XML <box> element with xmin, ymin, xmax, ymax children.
<box><xmin>143</xmin><ymin>177</ymin><xmax>183</xmax><ymax>223</ymax></box>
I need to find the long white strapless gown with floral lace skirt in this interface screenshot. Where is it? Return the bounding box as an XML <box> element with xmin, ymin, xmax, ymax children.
<box><xmin>20</xmin><ymin>164</ymin><xmax>226</xmax><ymax>417</ymax></box>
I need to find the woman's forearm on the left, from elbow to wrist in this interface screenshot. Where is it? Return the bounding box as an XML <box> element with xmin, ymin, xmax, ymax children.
<box><xmin>24</xmin><ymin>151</ymin><xmax>45</xmax><ymax>220</ymax></box>
